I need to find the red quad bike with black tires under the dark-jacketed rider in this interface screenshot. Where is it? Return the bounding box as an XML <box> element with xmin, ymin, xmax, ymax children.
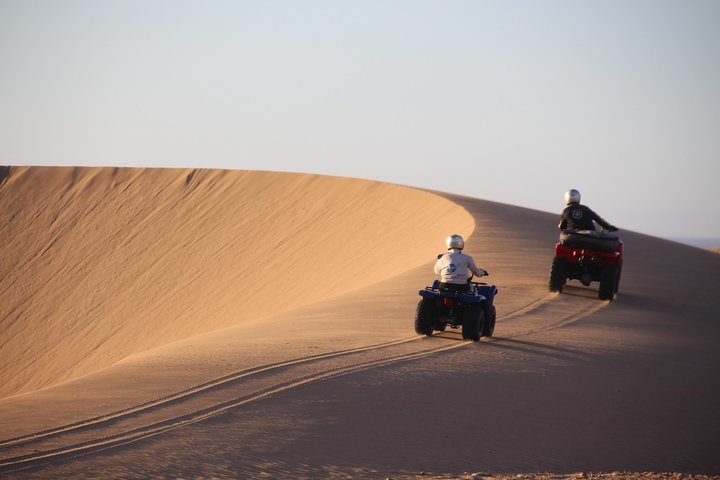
<box><xmin>548</xmin><ymin>230</ymin><xmax>623</xmax><ymax>300</ymax></box>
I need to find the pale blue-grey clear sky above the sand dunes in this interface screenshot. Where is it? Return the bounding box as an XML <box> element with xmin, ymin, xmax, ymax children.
<box><xmin>0</xmin><ymin>0</ymin><xmax>720</xmax><ymax>238</ymax></box>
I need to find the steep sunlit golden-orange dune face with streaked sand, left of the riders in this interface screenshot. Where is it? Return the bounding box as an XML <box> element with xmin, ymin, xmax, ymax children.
<box><xmin>0</xmin><ymin>167</ymin><xmax>474</xmax><ymax>396</ymax></box>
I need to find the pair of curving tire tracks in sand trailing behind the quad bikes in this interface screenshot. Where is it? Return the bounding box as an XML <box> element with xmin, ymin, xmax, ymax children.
<box><xmin>0</xmin><ymin>293</ymin><xmax>608</xmax><ymax>473</ymax></box>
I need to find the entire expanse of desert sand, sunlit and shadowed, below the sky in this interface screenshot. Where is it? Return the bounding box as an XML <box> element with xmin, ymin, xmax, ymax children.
<box><xmin>0</xmin><ymin>167</ymin><xmax>720</xmax><ymax>479</ymax></box>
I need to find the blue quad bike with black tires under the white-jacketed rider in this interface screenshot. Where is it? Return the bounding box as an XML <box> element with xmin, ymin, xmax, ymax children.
<box><xmin>415</xmin><ymin>278</ymin><xmax>498</xmax><ymax>342</ymax></box>
